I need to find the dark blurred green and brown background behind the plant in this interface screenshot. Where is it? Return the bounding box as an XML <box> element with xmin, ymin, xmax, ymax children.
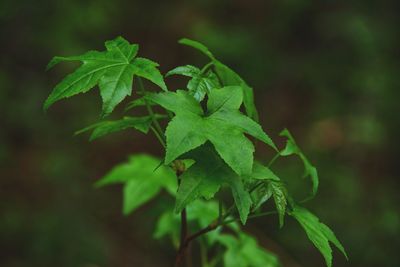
<box><xmin>0</xmin><ymin>0</ymin><xmax>400</xmax><ymax>267</ymax></box>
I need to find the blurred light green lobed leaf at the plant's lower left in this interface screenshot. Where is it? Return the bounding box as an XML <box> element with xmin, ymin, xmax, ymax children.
<box><xmin>96</xmin><ymin>154</ymin><xmax>176</xmax><ymax>215</ymax></box>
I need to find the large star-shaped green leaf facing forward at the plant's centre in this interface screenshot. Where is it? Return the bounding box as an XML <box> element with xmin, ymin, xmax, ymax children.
<box><xmin>148</xmin><ymin>87</ymin><xmax>275</xmax><ymax>175</ymax></box>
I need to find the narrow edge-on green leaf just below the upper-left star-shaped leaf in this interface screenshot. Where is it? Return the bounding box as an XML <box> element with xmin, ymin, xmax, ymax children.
<box><xmin>75</xmin><ymin>114</ymin><xmax>164</xmax><ymax>141</ymax></box>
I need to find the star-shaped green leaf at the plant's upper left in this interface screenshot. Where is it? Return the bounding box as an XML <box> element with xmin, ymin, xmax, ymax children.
<box><xmin>44</xmin><ymin>37</ymin><xmax>166</xmax><ymax>116</ymax></box>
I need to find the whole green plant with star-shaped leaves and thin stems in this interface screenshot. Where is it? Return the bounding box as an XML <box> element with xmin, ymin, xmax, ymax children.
<box><xmin>44</xmin><ymin>37</ymin><xmax>347</xmax><ymax>267</ymax></box>
